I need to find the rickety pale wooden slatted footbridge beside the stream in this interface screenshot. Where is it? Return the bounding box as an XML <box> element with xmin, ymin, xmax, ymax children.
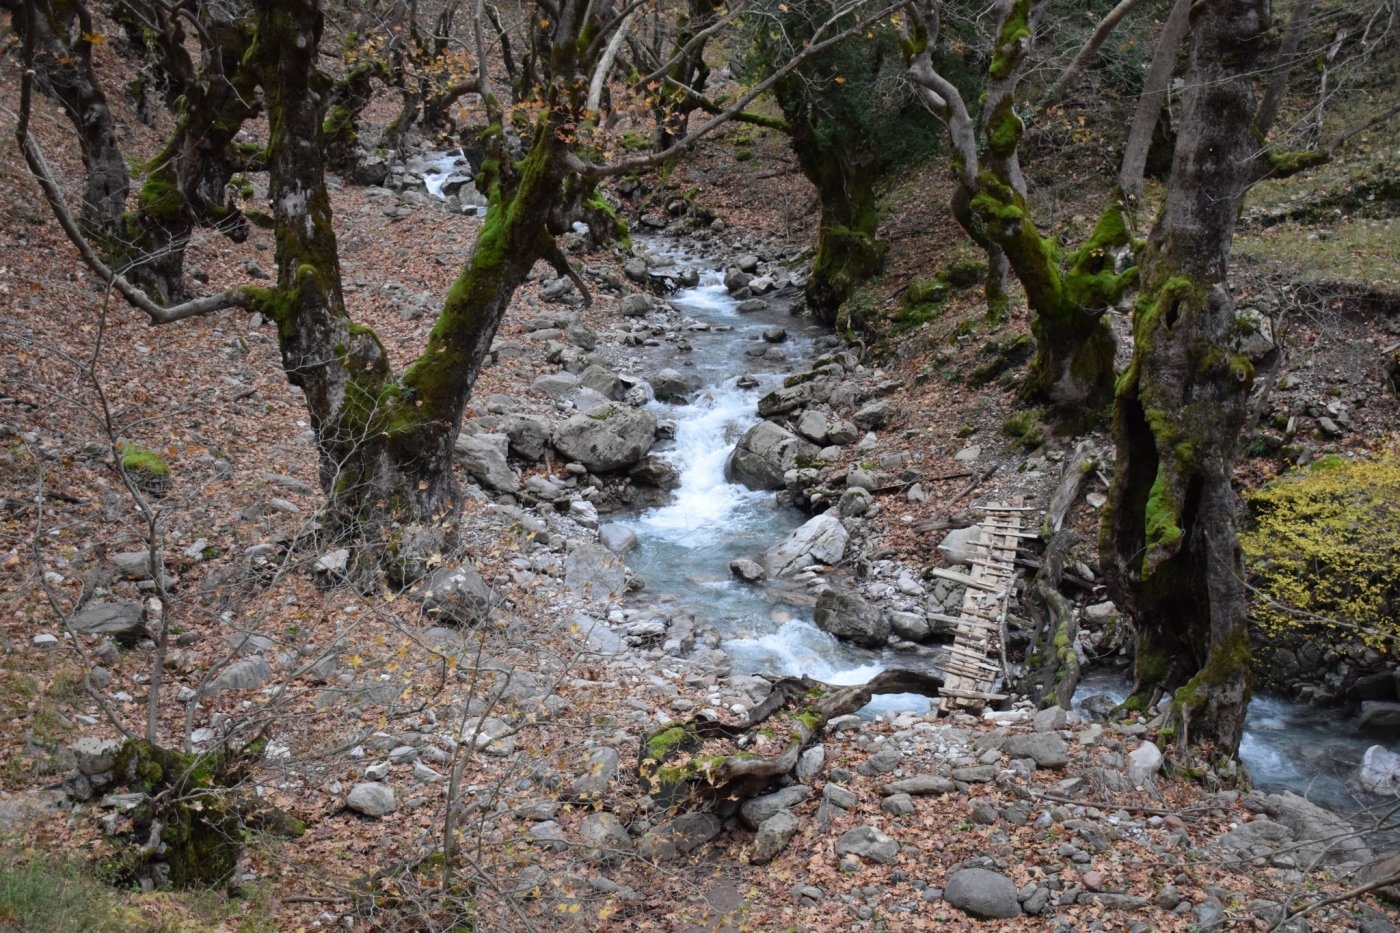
<box><xmin>931</xmin><ymin>496</ymin><xmax>1036</xmax><ymax>710</ymax></box>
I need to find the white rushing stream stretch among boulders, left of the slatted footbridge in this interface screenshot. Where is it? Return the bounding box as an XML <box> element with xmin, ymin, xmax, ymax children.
<box><xmin>620</xmin><ymin>244</ymin><xmax>928</xmax><ymax>714</ymax></box>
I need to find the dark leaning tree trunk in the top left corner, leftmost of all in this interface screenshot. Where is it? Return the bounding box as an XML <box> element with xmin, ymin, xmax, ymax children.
<box><xmin>0</xmin><ymin>0</ymin><xmax>130</xmax><ymax>245</ymax></box>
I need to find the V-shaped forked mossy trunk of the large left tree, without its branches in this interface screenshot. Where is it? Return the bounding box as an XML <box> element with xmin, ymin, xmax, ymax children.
<box><xmin>259</xmin><ymin>0</ymin><xmax>567</xmax><ymax>541</ymax></box>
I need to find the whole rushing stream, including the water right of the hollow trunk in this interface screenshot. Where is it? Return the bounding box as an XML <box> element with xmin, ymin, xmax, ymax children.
<box><xmin>607</xmin><ymin>242</ymin><xmax>1376</xmax><ymax>811</ymax></box>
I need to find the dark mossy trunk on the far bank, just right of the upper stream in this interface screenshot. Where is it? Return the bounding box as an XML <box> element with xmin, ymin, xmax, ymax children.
<box><xmin>791</xmin><ymin>118</ymin><xmax>889</xmax><ymax>324</ymax></box>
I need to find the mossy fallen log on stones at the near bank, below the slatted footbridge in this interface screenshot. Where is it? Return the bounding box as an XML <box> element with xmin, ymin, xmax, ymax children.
<box><xmin>637</xmin><ymin>671</ymin><xmax>944</xmax><ymax>808</ymax></box>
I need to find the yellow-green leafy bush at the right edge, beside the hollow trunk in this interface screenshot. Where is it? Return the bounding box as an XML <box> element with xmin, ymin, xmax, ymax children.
<box><xmin>1240</xmin><ymin>451</ymin><xmax>1400</xmax><ymax>654</ymax></box>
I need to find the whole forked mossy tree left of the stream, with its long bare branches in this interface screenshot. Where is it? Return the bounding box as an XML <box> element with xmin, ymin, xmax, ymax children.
<box><xmin>17</xmin><ymin>0</ymin><xmax>896</xmax><ymax>565</ymax></box>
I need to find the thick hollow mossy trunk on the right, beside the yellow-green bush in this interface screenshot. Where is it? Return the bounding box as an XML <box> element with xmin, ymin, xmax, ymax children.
<box><xmin>1100</xmin><ymin>0</ymin><xmax>1270</xmax><ymax>755</ymax></box>
